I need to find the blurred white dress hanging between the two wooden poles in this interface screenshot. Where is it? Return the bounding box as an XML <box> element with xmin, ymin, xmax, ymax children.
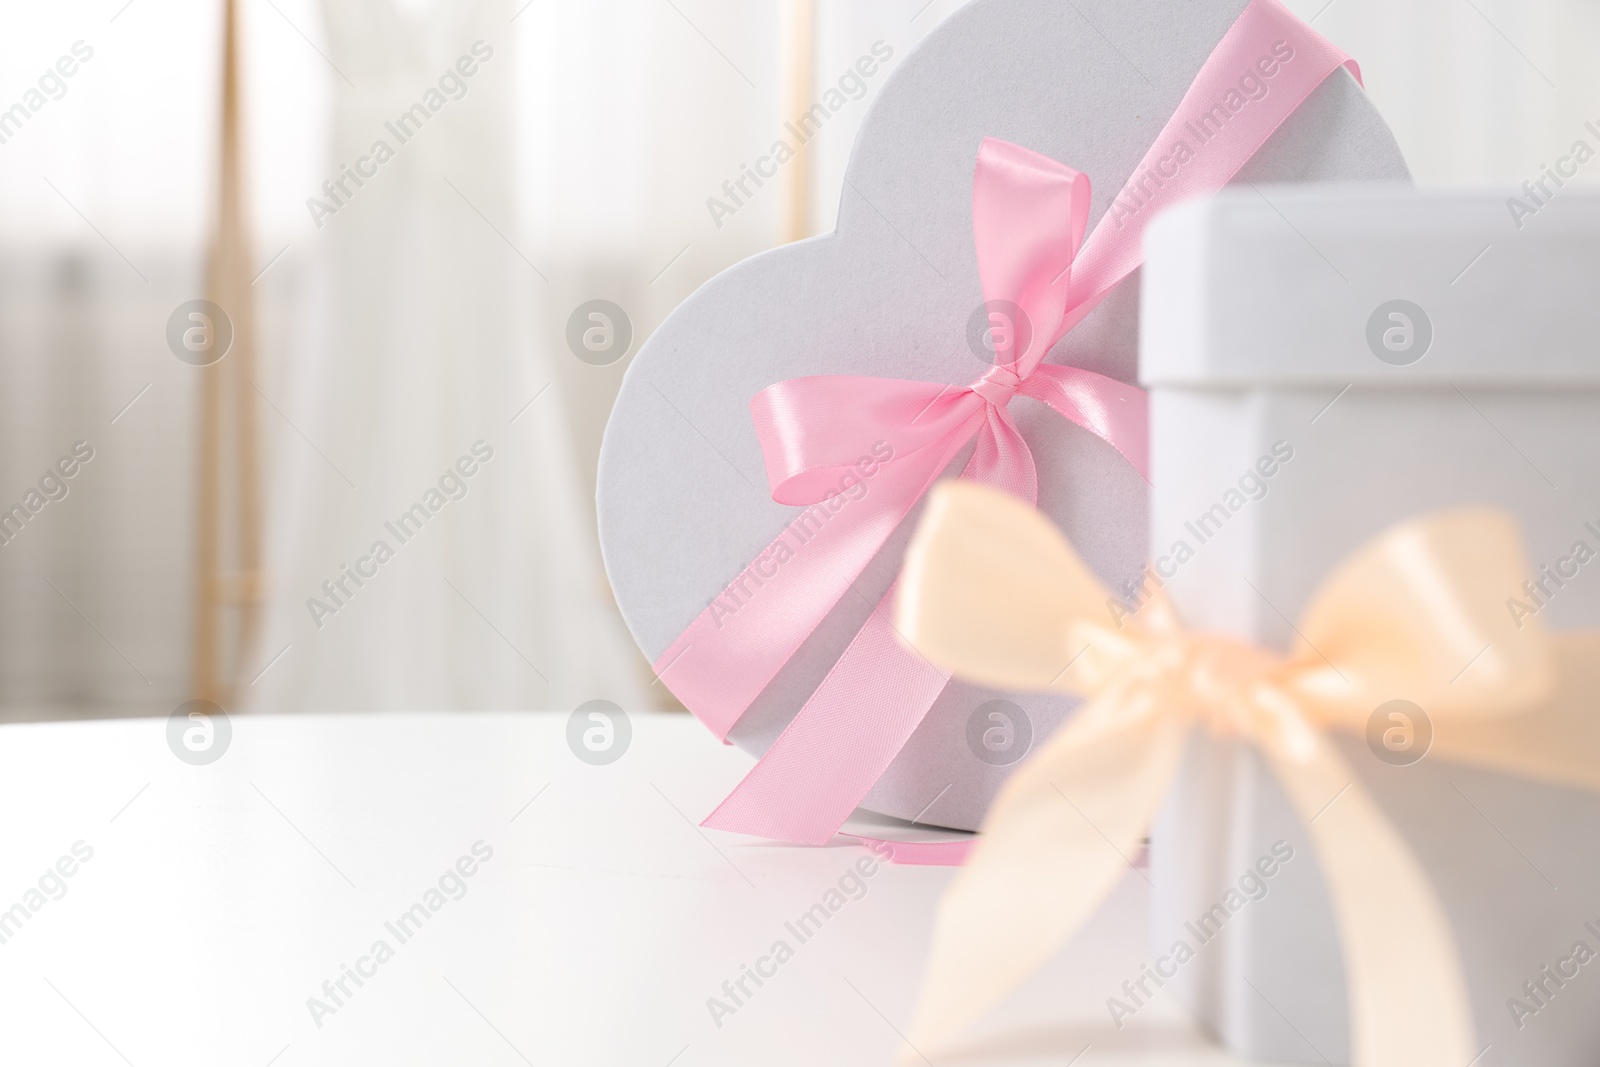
<box><xmin>246</xmin><ymin>0</ymin><xmax>643</xmax><ymax>710</ymax></box>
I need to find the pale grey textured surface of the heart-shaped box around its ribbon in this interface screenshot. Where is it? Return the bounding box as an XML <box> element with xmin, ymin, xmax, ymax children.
<box><xmin>598</xmin><ymin>0</ymin><xmax>1406</xmax><ymax>829</ymax></box>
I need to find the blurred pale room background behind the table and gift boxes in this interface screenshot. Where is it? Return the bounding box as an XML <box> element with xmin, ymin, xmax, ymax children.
<box><xmin>0</xmin><ymin>0</ymin><xmax>1600</xmax><ymax>721</ymax></box>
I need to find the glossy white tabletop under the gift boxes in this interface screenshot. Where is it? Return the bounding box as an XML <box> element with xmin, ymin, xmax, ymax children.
<box><xmin>0</xmin><ymin>712</ymin><xmax>1273</xmax><ymax>1067</ymax></box>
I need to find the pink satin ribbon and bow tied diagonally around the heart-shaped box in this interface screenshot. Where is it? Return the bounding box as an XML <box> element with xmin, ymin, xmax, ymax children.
<box><xmin>654</xmin><ymin>0</ymin><xmax>1360</xmax><ymax>862</ymax></box>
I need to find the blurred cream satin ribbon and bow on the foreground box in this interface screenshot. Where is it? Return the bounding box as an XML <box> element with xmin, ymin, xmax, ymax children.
<box><xmin>898</xmin><ymin>482</ymin><xmax>1600</xmax><ymax>1067</ymax></box>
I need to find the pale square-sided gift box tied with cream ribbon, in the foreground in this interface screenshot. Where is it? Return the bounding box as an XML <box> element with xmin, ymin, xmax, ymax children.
<box><xmin>1139</xmin><ymin>182</ymin><xmax>1600</xmax><ymax>1067</ymax></box>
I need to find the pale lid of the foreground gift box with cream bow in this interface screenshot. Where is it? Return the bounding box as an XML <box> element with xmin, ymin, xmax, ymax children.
<box><xmin>1139</xmin><ymin>181</ymin><xmax>1600</xmax><ymax>387</ymax></box>
